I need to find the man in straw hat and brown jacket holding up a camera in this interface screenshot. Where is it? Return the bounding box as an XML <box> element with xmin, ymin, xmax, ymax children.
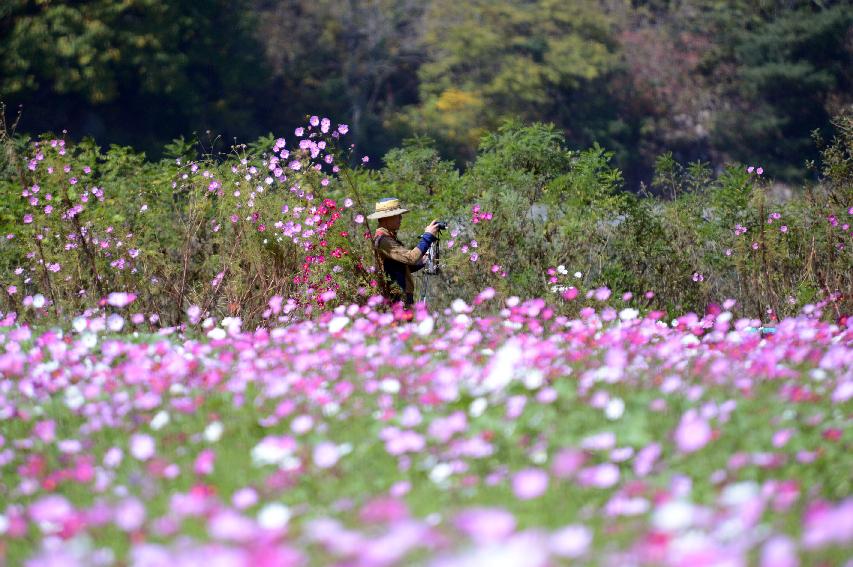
<box><xmin>367</xmin><ymin>198</ymin><xmax>438</xmax><ymax>307</ymax></box>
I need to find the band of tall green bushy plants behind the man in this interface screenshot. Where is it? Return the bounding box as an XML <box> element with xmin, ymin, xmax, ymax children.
<box><xmin>0</xmin><ymin>116</ymin><xmax>853</xmax><ymax>322</ymax></box>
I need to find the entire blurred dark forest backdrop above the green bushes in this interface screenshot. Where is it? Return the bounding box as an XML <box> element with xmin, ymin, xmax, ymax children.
<box><xmin>0</xmin><ymin>0</ymin><xmax>853</xmax><ymax>189</ymax></box>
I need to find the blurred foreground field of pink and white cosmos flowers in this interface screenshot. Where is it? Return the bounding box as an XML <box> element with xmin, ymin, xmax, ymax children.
<box><xmin>0</xmin><ymin>296</ymin><xmax>853</xmax><ymax>567</ymax></box>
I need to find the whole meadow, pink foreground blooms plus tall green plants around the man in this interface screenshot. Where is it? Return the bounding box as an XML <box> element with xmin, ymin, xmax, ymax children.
<box><xmin>0</xmin><ymin>112</ymin><xmax>853</xmax><ymax>567</ymax></box>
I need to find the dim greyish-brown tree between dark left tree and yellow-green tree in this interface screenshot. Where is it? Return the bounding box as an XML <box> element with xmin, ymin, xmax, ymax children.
<box><xmin>256</xmin><ymin>0</ymin><xmax>423</xmax><ymax>159</ymax></box>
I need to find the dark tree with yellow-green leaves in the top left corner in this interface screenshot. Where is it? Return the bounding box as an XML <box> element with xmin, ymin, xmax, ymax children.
<box><xmin>0</xmin><ymin>0</ymin><xmax>266</xmax><ymax>155</ymax></box>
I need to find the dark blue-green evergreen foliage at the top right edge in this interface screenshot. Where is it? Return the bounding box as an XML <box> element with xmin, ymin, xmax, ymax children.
<box><xmin>716</xmin><ymin>3</ymin><xmax>853</xmax><ymax>179</ymax></box>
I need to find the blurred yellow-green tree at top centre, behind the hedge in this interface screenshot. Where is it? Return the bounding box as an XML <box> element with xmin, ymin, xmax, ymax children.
<box><xmin>396</xmin><ymin>0</ymin><xmax>617</xmax><ymax>162</ymax></box>
